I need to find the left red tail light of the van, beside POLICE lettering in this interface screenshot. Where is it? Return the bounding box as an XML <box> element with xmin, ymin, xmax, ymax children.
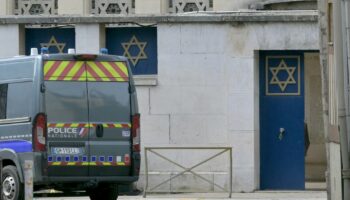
<box><xmin>33</xmin><ymin>113</ymin><xmax>47</xmax><ymax>152</ymax></box>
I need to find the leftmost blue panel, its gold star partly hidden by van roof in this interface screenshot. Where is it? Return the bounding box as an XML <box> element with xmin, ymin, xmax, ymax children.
<box><xmin>25</xmin><ymin>28</ymin><xmax>75</xmax><ymax>55</ymax></box>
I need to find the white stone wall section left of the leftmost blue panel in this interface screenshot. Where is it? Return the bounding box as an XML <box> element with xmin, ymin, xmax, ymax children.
<box><xmin>0</xmin><ymin>24</ymin><xmax>25</xmax><ymax>58</ymax></box>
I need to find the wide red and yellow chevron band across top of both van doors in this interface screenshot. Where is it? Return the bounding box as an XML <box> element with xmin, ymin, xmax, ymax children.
<box><xmin>44</xmin><ymin>61</ymin><xmax>129</xmax><ymax>82</ymax></box>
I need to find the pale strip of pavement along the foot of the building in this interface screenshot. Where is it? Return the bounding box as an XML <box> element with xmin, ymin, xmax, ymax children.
<box><xmin>34</xmin><ymin>191</ymin><xmax>327</xmax><ymax>200</ymax></box>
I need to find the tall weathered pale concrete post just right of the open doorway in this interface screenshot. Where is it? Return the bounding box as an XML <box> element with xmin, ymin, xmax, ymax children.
<box><xmin>318</xmin><ymin>0</ymin><xmax>341</xmax><ymax>200</ymax></box>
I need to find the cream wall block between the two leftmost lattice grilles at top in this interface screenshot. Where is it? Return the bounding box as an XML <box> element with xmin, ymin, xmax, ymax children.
<box><xmin>58</xmin><ymin>0</ymin><xmax>91</xmax><ymax>15</ymax></box>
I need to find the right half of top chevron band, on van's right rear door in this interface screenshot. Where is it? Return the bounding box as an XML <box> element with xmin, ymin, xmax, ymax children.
<box><xmin>86</xmin><ymin>61</ymin><xmax>129</xmax><ymax>81</ymax></box>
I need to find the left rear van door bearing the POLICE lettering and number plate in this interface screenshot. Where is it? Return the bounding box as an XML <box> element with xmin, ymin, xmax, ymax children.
<box><xmin>44</xmin><ymin>61</ymin><xmax>90</xmax><ymax>176</ymax></box>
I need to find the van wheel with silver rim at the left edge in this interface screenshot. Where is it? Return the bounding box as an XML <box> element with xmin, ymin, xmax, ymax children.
<box><xmin>2</xmin><ymin>165</ymin><xmax>24</xmax><ymax>200</ymax></box>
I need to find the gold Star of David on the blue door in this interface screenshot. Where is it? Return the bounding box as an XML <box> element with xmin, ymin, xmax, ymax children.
<box><xmin>270</xmin><ymin>60</ymin><xmax>297</xmax><ymax>92</ymax></box>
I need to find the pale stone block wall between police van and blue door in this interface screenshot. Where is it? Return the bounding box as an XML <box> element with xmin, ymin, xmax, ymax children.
<box><xmin>137</xmin><ymin>23</ymin><xmax>318</xmax><ymax>192</ymax></box>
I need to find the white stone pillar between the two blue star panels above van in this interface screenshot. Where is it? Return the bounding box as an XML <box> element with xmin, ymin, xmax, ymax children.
<box><xmin>75</xmin><ymin>24</ymin><xmax>106</xmax><ymax>54</ymax></box>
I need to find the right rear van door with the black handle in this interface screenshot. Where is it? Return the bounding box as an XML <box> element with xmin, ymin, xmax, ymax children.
<box><xmin>86</xmin><ymin>61</ymin><xmax>131</xmax><ymax>176</ymax></box>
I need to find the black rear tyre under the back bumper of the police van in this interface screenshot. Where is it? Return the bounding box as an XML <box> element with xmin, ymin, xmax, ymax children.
<box><xmin>87</xmin><ymin>185</ymin><xmax>118</xmax><ymax>200</ymax></box>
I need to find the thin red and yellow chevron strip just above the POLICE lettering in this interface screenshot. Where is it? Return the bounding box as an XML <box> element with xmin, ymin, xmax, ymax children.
<box><xmin>47</xmin><ymin>123</ymin><xmax>131</xmax><ymax>128</ymax></box>
